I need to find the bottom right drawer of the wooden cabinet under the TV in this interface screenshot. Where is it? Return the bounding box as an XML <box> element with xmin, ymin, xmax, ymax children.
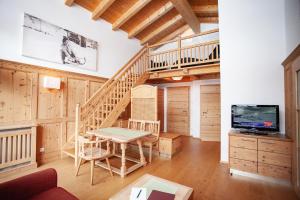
<box><xmin>258</xmin><ymin>163</ymin><xmax>292</xmax><ymax>180</ymax></box>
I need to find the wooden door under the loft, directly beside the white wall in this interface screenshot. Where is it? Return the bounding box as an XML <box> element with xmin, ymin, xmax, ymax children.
<box><xmin>200</xmin><ymin>85</ymin><xmax>221</xmax><ymax>141</ymax></box>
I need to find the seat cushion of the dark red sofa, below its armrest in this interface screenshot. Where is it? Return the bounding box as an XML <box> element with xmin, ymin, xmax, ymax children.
<box><xmin>30</xmin><ymin>187</ymin><xmax>77</xmax><ymax>200</ymax></box>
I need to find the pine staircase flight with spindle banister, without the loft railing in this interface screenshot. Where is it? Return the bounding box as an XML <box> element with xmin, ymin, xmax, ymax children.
<box><xmin>62</xmin><ymin>47</ymin><xmax>149</xmax><ymax>165</ymax></box>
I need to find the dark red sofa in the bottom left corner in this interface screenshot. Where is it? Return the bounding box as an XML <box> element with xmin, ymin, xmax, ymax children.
<box><xmin>0</xmin><ymin>169</ymin><xmax>78</xmax><ymax>200</ymax></box>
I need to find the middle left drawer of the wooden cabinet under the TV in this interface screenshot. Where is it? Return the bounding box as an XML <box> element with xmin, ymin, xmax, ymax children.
<box><xmin>230</xmin><ymin>147</ymin><xmax>257</xmax><ymax>162</ymax></box>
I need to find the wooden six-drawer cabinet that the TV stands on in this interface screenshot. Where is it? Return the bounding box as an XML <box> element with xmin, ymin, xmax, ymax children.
<box><xmin>229</xmin><ymin>131</ymin><xmax>292</xmax><ymax>181</ymax></box>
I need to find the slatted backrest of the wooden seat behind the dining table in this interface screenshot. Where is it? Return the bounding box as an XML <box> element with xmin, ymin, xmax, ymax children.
<box><xmin>128</xmin><ymin>119</ymin><xmax>160</xmax><ymax>137</ymax></box>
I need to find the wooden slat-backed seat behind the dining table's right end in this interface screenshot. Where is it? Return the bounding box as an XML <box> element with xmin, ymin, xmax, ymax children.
<box><xmin>128</xmin><ymin>119</ymin><xmax>160</xmax><ymax>163</ymax></box>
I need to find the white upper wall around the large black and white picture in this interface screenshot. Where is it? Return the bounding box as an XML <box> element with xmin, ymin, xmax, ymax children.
<box><xmin>0</xmin><ymin>0</ymin><xmax>141</xmax><ymax>77</ymax></box>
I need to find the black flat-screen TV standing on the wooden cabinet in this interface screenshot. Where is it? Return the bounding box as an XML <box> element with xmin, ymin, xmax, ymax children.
<box><xmin>231</xmin><ymin>105</ymin><xmax>279</xmax><ymax>131</ymax></box>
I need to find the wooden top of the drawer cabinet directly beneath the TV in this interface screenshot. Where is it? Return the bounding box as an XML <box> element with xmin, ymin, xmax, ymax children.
<box><xmin>229</xmin><ymin>131</ymin><xmax>292</xmax><ymax>142</ymax></box>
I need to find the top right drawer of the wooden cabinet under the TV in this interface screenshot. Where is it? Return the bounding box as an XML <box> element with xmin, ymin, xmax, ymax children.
<box><xmin>258</xmin><ymin>139</ymin><xmax>292</xmax><ymax>155</ymax></box>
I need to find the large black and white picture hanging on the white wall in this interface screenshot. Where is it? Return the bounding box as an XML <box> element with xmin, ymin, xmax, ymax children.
<box><xmin>22</xmin><ymin>13</ymin><xmax>98</xmax><ymax>71</ymax></box>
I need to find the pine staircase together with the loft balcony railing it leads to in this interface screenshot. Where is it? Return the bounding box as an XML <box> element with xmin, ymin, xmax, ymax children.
<box><xmin>62</xmin><ymin>29</ymin><xmax>220</xmax><ymax>165</ymax></box>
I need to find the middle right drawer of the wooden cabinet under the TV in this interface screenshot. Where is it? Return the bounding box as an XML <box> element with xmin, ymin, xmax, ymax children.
<box><xmin>258</xmin><ymin>151</ymin><xmax>292</xmax><ymax>167</ymax></box>
